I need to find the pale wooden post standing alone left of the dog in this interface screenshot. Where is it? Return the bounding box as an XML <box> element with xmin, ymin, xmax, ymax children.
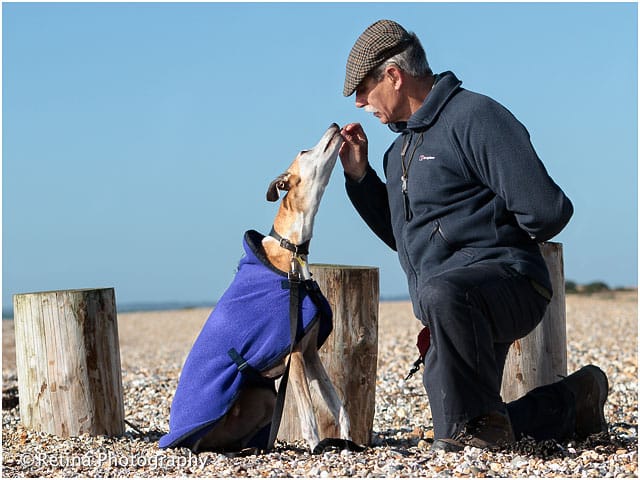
<box><xmin>13</xmin><ymin>288</ymin><xmax>124</xmax><ymax>437</ymax></box>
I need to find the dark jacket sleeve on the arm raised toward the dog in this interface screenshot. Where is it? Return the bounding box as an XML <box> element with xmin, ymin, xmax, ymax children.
<box><xmin>345</xmin><ymin>165</ymin><xmax>396</xmax><ymax>250</ymax></box>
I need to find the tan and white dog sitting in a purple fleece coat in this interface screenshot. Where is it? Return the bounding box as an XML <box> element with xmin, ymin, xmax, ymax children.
<box><xmin>160</xmin><ymin>123</ymin><xmax>350</xmax><ymax>452</ymax></box>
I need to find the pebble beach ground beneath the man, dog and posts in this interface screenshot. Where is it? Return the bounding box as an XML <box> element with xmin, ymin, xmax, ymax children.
<box><xmin>2</xmin><ymin>291</ymin><xmax>638</xmax><ymax>478</ymax></box>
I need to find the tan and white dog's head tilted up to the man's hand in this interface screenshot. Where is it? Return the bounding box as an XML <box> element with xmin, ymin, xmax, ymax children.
<box><xmin>267</xmin><ymin>123</ymin><xmax>343</xmax><ymax>213</ymax></box>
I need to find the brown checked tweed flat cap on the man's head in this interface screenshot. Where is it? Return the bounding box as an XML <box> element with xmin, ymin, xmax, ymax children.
<box><xmin>342</xmin><ymin>20</ymin><xmax>412</xmax><ymax>97</ymax></box>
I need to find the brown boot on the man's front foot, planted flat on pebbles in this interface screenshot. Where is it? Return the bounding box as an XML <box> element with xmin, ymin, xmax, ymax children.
<box><xmin>431</xmin><ymin>412</ymin><xmax>516</xmax><ymax>452</ymax></box>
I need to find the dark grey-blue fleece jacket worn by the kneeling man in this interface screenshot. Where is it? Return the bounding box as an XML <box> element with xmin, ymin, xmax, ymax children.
<box><xmin>346</xmin><ymin>72</ymin><xmax>573</xmax><ymax>314</ymax></box>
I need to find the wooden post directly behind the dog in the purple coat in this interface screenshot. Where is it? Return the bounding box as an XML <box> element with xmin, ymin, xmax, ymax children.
<box><xmin>278</xmin><ymin>265</ymin><xmax>380</xmax><ymax>445</ymax></box>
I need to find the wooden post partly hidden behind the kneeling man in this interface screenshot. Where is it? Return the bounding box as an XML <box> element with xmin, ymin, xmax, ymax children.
<box><xmin>501</xmin><ymin>242</ymin><xmax>567</xmax><ymax>402</ymax></box>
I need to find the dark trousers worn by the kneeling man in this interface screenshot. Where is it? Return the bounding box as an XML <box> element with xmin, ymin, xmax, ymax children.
<box><xmin>420</xmin><ymin>264</ymin><xmax>575</xmax><ymax>440</ymax></box>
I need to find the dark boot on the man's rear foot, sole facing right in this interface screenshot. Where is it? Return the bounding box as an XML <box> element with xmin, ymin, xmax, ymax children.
<box><xmin>559</xmin><ymin>365</ymin><xmax>609</xmax><ymax>439</ymax></box>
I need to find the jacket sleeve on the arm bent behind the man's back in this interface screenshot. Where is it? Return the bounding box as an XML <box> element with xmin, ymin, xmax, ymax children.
<box><xmin>463</xmin><ymin>98</ymin><xmax>573</xmax><ymax>242</ymax></box>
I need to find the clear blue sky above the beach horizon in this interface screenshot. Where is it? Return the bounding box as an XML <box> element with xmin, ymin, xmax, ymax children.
<box><xmin>2</xmin><ymin>3</ymin><xmax>638</xmax><ymax>307</ymax></box>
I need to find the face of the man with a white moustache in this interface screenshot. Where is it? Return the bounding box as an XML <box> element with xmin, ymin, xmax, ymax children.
<box><xmin>356</xmin><ymin>72</ymin><xmax>401</xmax><ymax>124</ymax></box>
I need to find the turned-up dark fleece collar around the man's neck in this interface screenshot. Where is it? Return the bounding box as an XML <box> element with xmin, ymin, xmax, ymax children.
<box><xmin>389</xmin><ymin>71</ymin><xmax>462</xmax><ymax>133</ymax></box>
